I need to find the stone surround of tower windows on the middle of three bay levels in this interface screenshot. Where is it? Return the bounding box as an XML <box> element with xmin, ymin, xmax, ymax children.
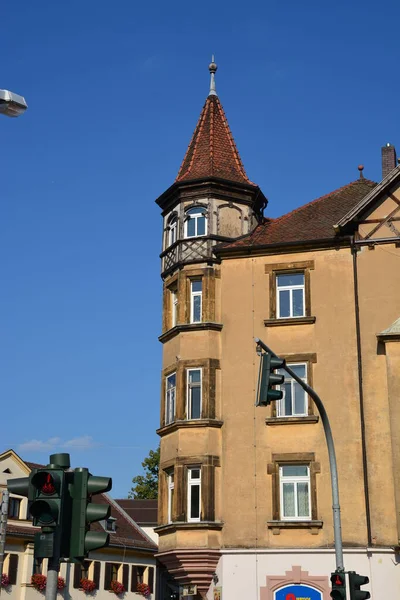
<box><xmin>158</xmin><ymin>358</ymin><xmax>221</xmax><ymax>428</ymax></box>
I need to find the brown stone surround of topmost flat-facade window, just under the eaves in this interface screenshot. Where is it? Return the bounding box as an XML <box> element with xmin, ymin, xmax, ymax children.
<box><xmin>264</xmin><ymin>260</ymin><xmax>315</xmax><ymax>327</ymax></box>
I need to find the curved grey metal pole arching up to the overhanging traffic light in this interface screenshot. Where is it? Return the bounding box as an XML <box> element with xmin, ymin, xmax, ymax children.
<box><xmin>256</xmin><ymin>338</ymin><xmax>344</xmax><ymax>572</ymax></box>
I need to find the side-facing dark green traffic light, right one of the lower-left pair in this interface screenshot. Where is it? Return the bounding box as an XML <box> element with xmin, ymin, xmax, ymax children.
<box><xmin>69</xmin><ymin>468</ymin><xmax>112</xmax><ymax>559</ymax></box>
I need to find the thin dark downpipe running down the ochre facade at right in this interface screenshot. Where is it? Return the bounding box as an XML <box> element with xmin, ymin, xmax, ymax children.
<box><xmin>350</xmin><ymin>235</ymin><xmax>372</xmax><ymax>547</ymax></box>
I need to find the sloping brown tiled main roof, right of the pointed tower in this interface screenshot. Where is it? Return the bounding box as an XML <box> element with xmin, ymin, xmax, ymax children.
<box><xmin>217</xmin><ymin>178</ymin><xmax>376</xmax><ymax>253</ymax></box>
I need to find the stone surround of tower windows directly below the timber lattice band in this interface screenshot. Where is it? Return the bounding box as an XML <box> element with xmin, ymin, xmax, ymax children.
<box><xmin>161</xmin><ymin>267</ymin><xmax>220</xmax><ymax>341</ymax></box>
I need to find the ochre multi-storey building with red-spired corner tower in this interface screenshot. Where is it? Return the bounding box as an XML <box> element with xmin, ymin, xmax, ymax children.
<box><xmin>156</xmin><ymin>62</ymin><xmax>400</xmax><ymax>600</ymax></box>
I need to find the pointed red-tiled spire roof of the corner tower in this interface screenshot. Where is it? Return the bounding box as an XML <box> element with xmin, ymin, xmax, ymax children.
<box><xmin>176</xmin><ymin>95</ymin><xmax>254</xmax><ymax>185</ymax></box>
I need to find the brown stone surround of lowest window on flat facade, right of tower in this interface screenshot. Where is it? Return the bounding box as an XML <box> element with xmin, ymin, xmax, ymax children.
<box><xmin>267</xmin><ymin>452</ymin><xmax>323</xmax><ymax>535</ymax></box>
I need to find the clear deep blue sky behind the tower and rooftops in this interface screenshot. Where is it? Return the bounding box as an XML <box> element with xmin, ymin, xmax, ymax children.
<box><xmin>0</xmin><ymin>0</ymin><xmax>400</xmax><ymax>497</ymax></box>
